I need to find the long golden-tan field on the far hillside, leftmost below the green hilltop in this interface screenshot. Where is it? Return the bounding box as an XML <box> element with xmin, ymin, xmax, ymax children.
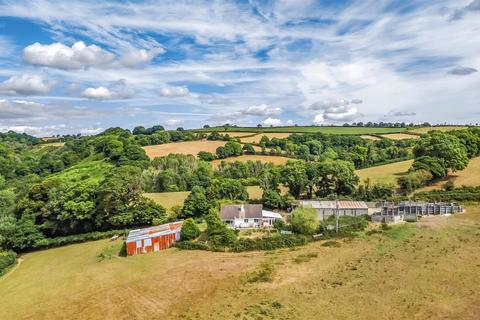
<box><xmin>143</xmin><ymin>140</ymin><xmax>225</xmax><ymax>159</ymax></box>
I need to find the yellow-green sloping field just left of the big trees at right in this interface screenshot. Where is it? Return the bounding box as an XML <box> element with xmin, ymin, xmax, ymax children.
<box><xmin>356</xmin><ymin>160</ymin><xmax>413</xmax><ymax>185</ymax></box>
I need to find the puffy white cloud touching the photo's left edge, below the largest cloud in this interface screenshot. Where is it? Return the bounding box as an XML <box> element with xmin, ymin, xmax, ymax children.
<box><xmin>0</xmin><ymin>74</ymin><xmax>53</xmax><ymax>95</ymax></box>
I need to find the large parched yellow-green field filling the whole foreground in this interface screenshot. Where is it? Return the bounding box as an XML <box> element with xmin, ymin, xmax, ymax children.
<box><xmin>0</xmin><ymin>208</ymin><xmax>480</xmax><ymax>319</ymax></box>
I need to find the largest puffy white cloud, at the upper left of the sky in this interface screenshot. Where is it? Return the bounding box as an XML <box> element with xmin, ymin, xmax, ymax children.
<box><xmin>23</xmin><ymin>41</ymin><xmax>115</xmax><ymax>69</ymax></box>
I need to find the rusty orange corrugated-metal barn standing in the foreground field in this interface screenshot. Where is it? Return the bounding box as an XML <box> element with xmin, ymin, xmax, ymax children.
<box><xmin>126</xmin><ymin>221</ymin><xmax>182</xmax><ymax>256</ymax></box>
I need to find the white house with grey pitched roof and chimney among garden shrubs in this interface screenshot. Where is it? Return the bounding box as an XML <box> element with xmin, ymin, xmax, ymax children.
<box><xmin>220</xmin><ymin>204</ymin><xmax>283</xmax><ymax>228</ymax></box>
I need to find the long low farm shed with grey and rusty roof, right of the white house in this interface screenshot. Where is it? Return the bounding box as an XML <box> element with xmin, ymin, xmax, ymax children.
<box><xmin>297</xmin><ymin>200</ymin><xmax>368</xmax><ymax>221</ymax></box>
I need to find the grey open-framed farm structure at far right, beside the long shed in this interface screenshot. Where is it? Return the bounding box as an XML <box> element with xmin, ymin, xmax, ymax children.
<box><xmin>372</xmin><ymin>201</ymin><xmax>463</xmax><ymax>223</ymax></box>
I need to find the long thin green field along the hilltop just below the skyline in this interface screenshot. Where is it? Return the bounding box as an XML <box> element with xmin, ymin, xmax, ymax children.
<box><xmin>192</xmin><ymin>126</ymin><xmax>406</xmax><ymax>135</ymax></box>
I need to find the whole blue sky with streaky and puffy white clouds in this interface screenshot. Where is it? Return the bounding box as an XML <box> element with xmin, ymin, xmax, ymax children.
<box><xmin>0</xmin><ymin>0</ymin><xmax>480</xmax><ymax>136</ymax></box>
